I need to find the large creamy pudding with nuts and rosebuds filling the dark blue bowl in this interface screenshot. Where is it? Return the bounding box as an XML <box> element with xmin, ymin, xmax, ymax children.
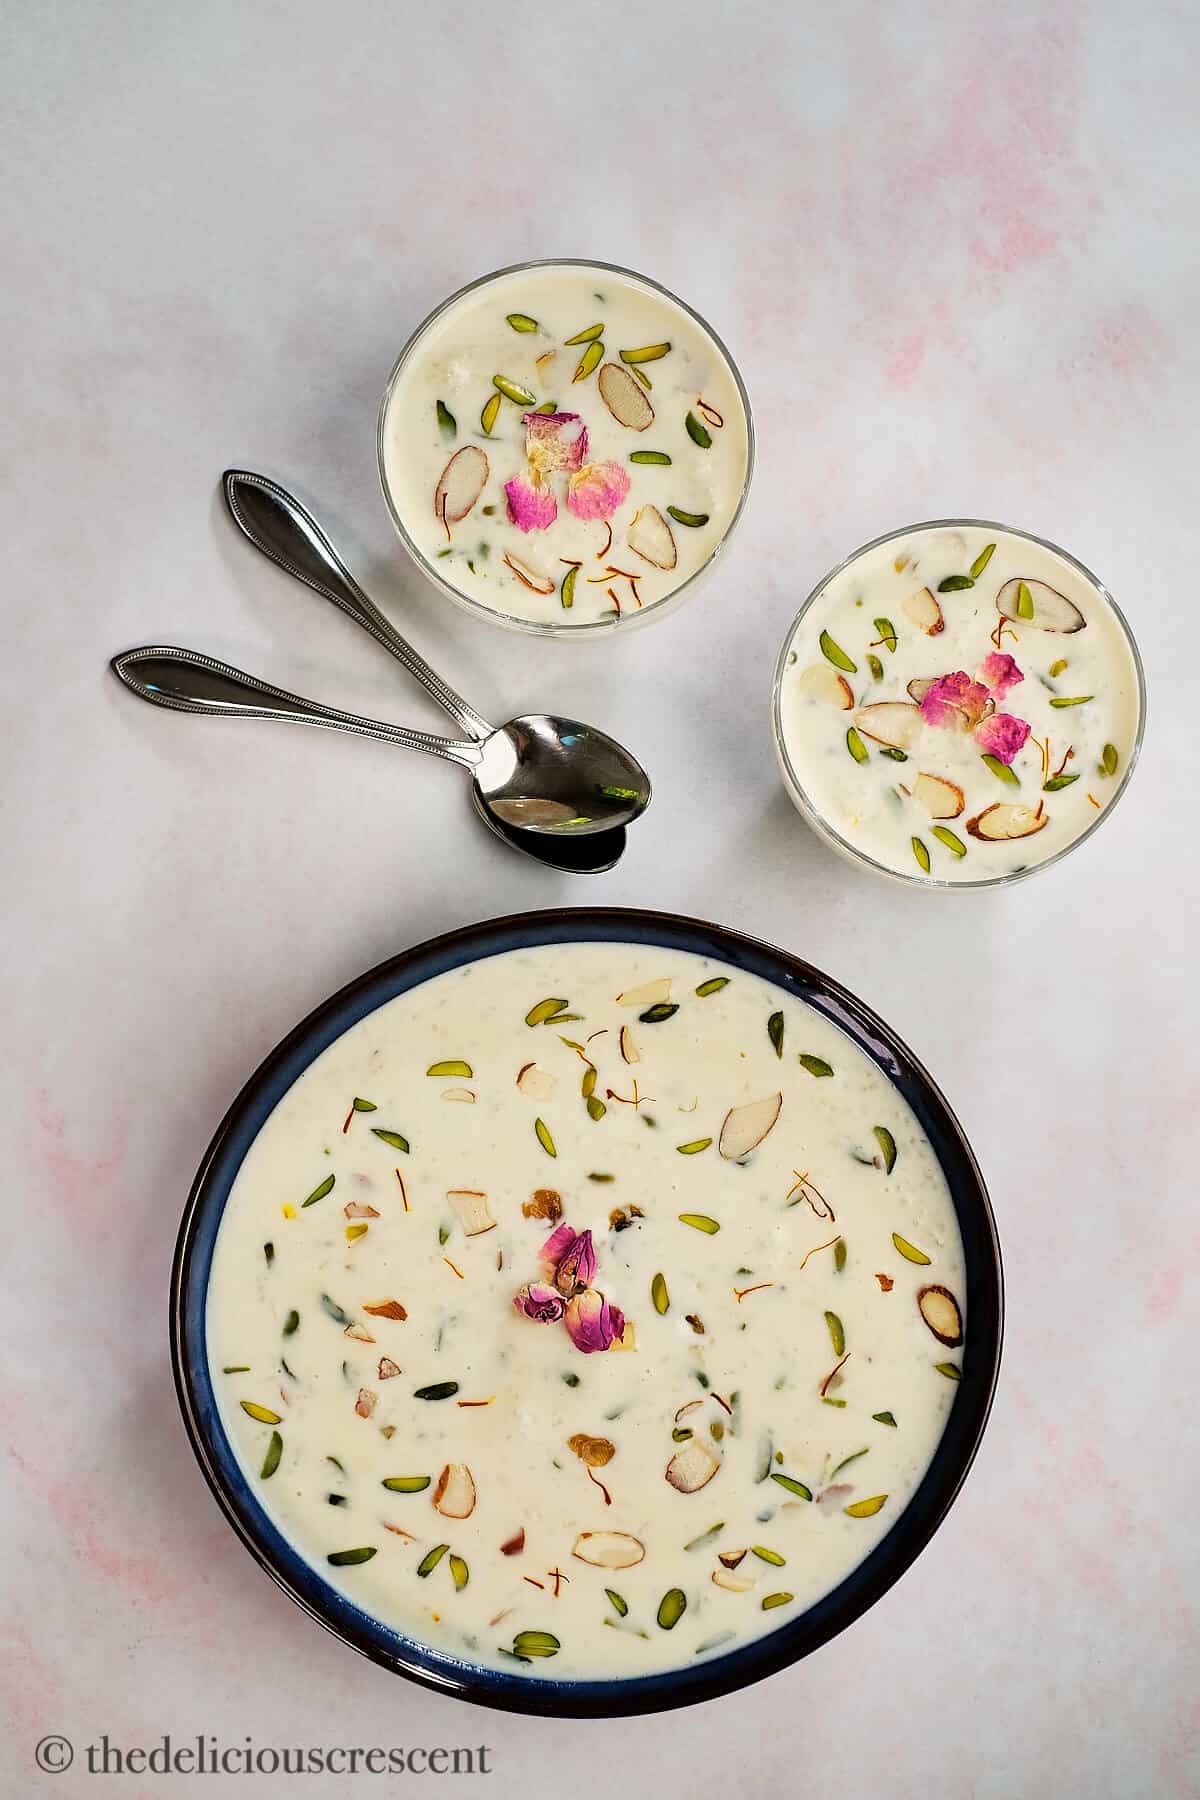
<box><xmin>207</xmin><ymin>943</ymin><xmax>970</xmax><ymax>1679</ymax></box>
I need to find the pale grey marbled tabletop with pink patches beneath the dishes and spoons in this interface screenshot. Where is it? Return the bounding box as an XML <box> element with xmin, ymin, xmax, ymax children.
<box><xmin>0</xmin><ymin>0</ymin><xmax>1200</xmax><ymax>1800</ymax></box>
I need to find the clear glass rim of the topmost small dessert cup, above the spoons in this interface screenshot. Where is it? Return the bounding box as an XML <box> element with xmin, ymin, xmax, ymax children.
<box><xmin>376</xmin><ymin>256</ymin><xmax>756</xmax><ymax>643</ymax></box>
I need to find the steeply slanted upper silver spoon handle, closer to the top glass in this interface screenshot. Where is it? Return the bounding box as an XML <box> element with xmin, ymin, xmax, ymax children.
<box><xmin>221</xmin><ymin>468</ymin><xmax>491</xmax><ymax>742</ymax></box>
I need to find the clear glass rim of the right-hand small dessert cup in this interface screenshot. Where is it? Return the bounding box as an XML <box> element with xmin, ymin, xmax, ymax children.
<box><xmin>770</xmin><ymin>518</ymin><xmax>1148</xmax><ymax>893</ymax></box>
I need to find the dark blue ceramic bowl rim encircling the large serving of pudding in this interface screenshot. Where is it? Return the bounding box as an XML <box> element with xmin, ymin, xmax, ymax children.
<box><xmin>171</xmin><ymin>907</ymin><xmax>1004</xmax><ymax>1719</ymax></box>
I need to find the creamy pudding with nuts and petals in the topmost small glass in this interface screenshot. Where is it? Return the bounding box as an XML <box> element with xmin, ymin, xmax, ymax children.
<box><xmin>380</xmin><ymin>263</ymin><xmax>750</xmax><ymax>632</ymax></box>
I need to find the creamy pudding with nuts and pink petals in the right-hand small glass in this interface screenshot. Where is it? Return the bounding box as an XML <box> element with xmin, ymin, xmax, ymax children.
<box><xmin>774</xmin><ymin>524</ymin><xmax>1142</xmax><ymax>884</ymax></box>
